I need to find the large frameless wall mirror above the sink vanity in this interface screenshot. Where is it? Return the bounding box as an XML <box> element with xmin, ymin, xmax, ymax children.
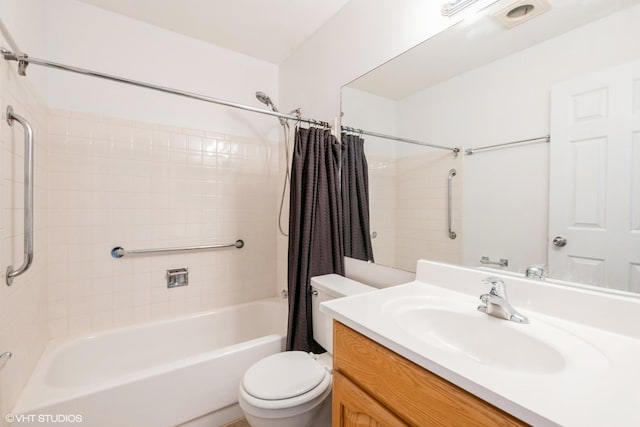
<box><xmin>342</xmin><ymin>0</ymin><xmax>640</xmax><ymax>293</ymax></box>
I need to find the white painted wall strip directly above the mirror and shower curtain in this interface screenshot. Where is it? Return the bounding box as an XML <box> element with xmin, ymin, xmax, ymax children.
<box><xmin>280</xmin><ymin>0</ymin><xmax>456</xmax><ymax>123</ymax></box>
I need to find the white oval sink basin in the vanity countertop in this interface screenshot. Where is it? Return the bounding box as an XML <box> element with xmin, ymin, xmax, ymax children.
<box><xmin>383</xmin><ymin>297</ymin><xmax>606</xmax><ymax>374</ymax></box>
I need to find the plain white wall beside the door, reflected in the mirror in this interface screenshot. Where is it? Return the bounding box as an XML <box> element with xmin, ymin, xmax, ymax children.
<box><xmin>398</xmin><ymin>7</ymin><xmax>640</xmax><ymax>272</ymax></box>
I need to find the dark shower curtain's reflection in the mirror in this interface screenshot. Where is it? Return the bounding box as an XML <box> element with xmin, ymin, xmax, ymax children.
<box><xmin>341</xmin><ymin>133</ymin><xmax>373</xmax><ymax>262</ymax></box>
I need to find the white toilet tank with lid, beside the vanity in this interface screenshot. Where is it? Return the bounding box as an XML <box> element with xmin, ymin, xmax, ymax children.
<box><xmin>311</xmin><ymin>274</ymin><xmax>376</xmax><ymax>354</ymax></box>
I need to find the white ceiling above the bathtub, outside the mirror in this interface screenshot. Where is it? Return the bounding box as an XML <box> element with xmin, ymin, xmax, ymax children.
<box><xmin>80</xmin><ymin>0</ymin><xmax>356</xmax><ymax>64</ymax></box>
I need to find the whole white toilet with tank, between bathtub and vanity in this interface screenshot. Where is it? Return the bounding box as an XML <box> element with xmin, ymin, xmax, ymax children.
<box><xmin>238</xmin><ymin>274</ymin><xmax>375</xmax><ymax>427</ymax></box>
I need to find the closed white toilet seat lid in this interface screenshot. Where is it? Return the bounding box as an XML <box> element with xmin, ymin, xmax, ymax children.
<box><xmin>240</xmin><ymin>351</ymin><xmax>332</xmax><ymax>409</ymax></box>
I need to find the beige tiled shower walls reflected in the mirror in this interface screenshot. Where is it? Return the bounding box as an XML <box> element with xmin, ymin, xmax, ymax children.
<box><xmin>367</xmin><ymin>151</ymin><xmax>463</xmax><ymax>271</ymax></box>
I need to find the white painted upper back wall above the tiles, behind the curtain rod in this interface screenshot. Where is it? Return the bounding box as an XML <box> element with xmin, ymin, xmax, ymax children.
<box><xmin>41</xmin><ymin>0</ymin><xmax>279</xmax><ymax>139</ymax></box>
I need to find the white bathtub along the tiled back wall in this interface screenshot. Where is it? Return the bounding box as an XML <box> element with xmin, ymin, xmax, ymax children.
<box><xmin>14</xmin><ymin>299</ymin><xmax>287</xmax><ymax>427</ymax></box>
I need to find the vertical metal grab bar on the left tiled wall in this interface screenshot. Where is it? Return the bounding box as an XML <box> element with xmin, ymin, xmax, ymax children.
<box><xmin>6</xmin><ymin>105</ymin><xmax>33</xmax><ymax>286</ymax></box>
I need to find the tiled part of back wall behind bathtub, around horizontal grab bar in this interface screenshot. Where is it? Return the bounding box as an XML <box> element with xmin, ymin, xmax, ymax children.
<box><xmin>48</xmin><ymin>111</ymin><xmax>277</xmax><ymax>338</ymax></box>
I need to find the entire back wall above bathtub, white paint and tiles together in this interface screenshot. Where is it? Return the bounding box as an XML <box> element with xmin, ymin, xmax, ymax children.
<box><xmin>31</xmin><ymin>0</ymin><xmax>280</xmax><ymax>338</ymax></box>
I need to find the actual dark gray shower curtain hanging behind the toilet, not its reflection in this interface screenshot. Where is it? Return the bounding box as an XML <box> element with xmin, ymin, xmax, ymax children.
<box><xmin>287</xmin><ymin>128</ymin><xmax>344</xmax><ymax>353</ymax></box>
